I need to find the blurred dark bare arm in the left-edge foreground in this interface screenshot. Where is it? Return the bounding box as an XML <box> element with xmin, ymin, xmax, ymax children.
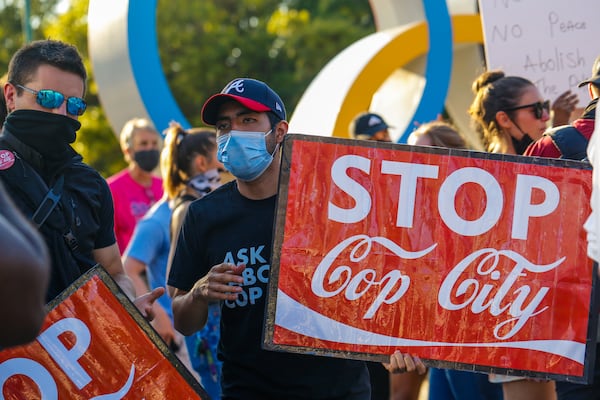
<box><xmin>0</xmin><ymin>186</ymin><xmax>50</xmax><ymax>347</ymax></box>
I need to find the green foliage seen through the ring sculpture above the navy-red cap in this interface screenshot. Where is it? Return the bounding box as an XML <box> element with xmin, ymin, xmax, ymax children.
<box><xmin>157</xmin><ymin>0</ymin><xmax>375</xmax><ymax>125</ymax></box>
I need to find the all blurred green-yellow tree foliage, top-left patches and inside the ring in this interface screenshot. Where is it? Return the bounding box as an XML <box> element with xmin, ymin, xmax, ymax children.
<box><xmin>0</xmin><ymin>0</ymin><xmax>375</xmax><ymax>176</ymax></box>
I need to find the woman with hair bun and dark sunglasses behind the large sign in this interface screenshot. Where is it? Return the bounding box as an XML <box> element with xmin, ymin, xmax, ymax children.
<box><xmin>469</xmin><ymin>70</ymin><xmax>556</xmax><ymax>400</ymax></box>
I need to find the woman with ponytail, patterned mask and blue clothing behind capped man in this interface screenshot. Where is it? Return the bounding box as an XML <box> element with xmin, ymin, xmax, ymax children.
<box><xmin>123</xmin><ymin>123</ymin><xmax>221</xmax><ymax>399</ymax></box>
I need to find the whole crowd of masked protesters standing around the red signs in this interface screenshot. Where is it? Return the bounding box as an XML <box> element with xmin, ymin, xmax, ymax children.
<box><xmin>0</xmin><ymin>40</ymin><xmax>600</xmax><ymax>400</ymax></box>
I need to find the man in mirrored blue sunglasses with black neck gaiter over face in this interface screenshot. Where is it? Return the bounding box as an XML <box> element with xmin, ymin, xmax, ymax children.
<box><xmin>0</xmin><ymin>40</ymin><xmax>164</xmax><ymax>319</ymax></box>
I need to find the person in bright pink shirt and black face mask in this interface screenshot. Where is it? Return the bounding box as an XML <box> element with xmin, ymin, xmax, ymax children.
<box><xmin>107</xmin><ymin>118</ymin><xmax>163</xmax><ymax>254</ymax></box>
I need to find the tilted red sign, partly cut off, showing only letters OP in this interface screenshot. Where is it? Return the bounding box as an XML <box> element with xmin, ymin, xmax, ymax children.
<box><xmin>0</xmin><ymin>267</ymin><xmax>208</xmax><ymax>400</ymax></box>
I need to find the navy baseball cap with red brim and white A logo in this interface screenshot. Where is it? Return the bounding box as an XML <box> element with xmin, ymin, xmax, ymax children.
<box><xmin>202</xmin><ymin>78</ymin><xmax>286</xmax><ymax>125</ymax></box>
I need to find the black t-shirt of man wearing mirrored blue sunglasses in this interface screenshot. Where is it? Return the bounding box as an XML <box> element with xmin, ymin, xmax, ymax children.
<box><xmin>0</xmin><ymin>142</ymin><xmax>115</xmax><ymax>302</ymax></box>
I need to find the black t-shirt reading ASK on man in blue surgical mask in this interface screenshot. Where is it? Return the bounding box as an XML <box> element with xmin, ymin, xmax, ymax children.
<box><xmin>168</xmin><ymin>181</ymin><xmax>369</xmax><ymax>399</ymax></box>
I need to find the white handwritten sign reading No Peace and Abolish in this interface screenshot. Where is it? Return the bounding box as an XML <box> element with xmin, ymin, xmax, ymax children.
<box><xmin>479</xmin><ymin>0</ymin><xmax>600</xmax><ymax>103</ymax></box>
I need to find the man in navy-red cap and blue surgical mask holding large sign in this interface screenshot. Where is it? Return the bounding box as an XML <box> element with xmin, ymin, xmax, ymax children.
<box><xmin>168</xmin><ymin>78</ymin><xmax>425</xmax><ymax>400</ymax></box>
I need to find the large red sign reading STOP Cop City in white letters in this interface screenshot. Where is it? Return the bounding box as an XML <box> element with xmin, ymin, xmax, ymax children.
<box><xmin>265</xmin><ymin>135</ymin><xmax>596</xmax><ymax>381</ymax></box>
